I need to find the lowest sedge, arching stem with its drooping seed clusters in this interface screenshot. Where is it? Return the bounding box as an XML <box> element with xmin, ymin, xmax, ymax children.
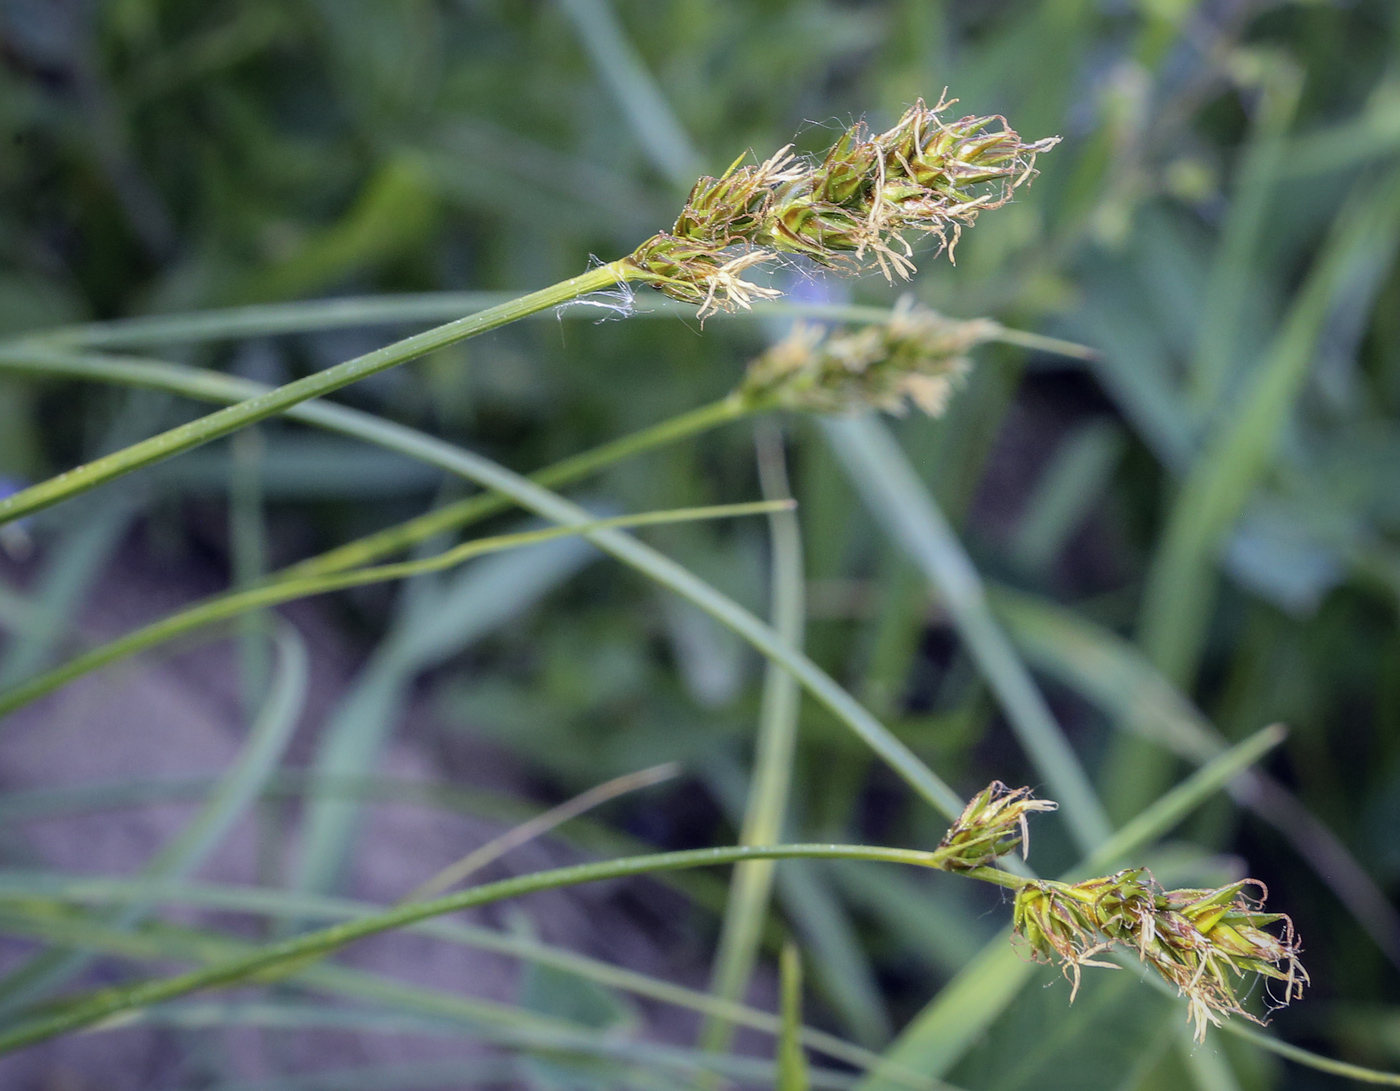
<box><xmin>0</xmin><ymin>773</ymin><xmax>1308</xmax><ymax>1052</ymax></box>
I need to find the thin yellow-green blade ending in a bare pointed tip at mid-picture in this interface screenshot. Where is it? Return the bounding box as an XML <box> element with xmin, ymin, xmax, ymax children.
<box><xmin>0</xmin><ymin>503</ymin><xmax>777</xmax><ymax>717</ymax></box>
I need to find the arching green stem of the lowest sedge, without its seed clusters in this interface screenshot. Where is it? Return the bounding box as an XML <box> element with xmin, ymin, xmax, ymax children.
<box><xmin>0</xmin><ymin>845</ymin><xmax>939</xmax><ymax>1053</ymax></box>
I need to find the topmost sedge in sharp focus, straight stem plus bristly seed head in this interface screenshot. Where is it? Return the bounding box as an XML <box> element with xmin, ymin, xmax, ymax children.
<box><xmin>0</xmin><ymin>99</ymin><xmax>1056</xmax><ymax>525</ymax></box>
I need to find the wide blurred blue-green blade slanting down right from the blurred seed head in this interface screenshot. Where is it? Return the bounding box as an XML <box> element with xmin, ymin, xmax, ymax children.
<box><xmin>823</xmin><ymin>417</ymin><xmax>1109</xmax><ymax>853</ymax></box>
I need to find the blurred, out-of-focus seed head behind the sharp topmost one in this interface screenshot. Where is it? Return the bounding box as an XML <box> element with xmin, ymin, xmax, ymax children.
<box><xmin>739</xmin><ymin>296</ymin><xmax>998</xmax><ymax>416</ymax></box>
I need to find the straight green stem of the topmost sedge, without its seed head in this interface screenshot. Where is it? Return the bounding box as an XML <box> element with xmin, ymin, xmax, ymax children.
<box><xmin>0</xmin><ymin>262</ymin><xmax>631</xmax><ymax>527</ymax></box>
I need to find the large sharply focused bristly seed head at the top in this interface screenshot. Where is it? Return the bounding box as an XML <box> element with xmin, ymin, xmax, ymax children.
<box><xmin>624</xmin><ymin>98</ymin><xmax>1058</xmax><ymax>318</ymax></box>
